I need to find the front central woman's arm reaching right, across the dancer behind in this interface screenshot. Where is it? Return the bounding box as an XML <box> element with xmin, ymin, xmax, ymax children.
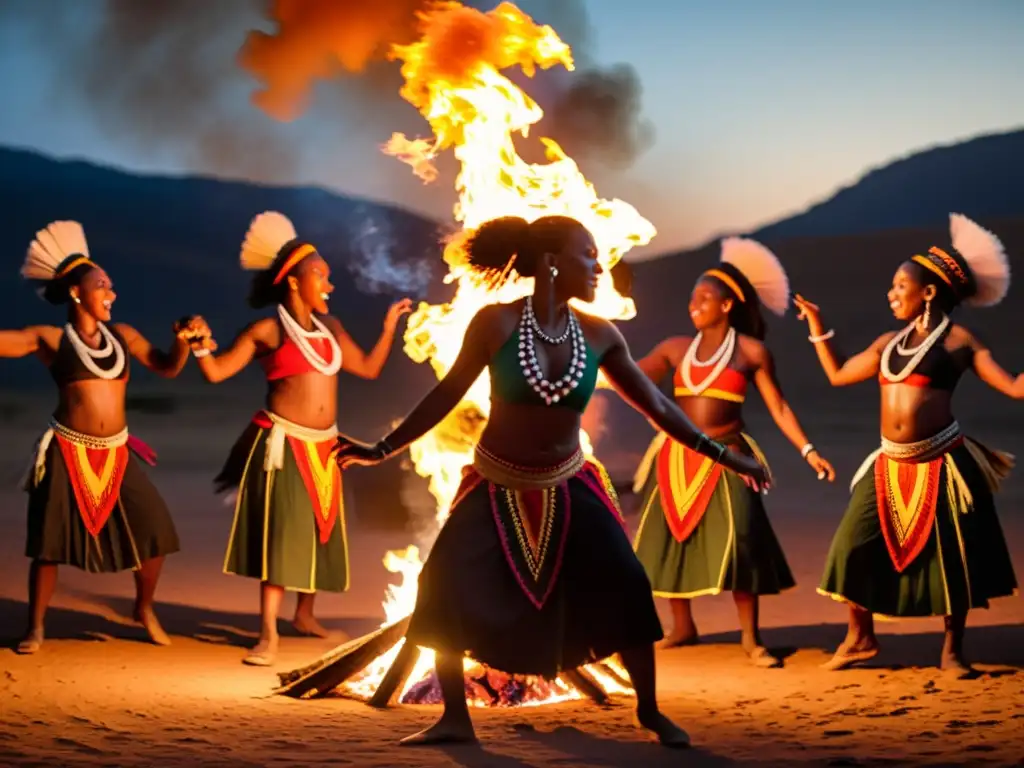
<box><xmin>601</xmin><ymin>323</ymin><xmax>763</xmax><ymax>476</ymax></box>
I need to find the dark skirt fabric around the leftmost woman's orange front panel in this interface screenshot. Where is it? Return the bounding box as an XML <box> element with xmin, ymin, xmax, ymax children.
<box><xmin>25</xmin><ymin>436</ymin><xmax>180</xmax><ymax>573</ymax></box>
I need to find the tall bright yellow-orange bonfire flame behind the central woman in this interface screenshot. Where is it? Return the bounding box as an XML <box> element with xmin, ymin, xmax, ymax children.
<box><xmin>346</xmin><ymin>2</ymin><xmax>655</xmax><ymax>703</ymax></box>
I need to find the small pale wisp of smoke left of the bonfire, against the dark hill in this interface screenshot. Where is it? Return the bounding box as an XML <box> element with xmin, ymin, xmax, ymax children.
<box><xmin>345</xmin><ymin>206</ymin><xmax>433</xmax><ymax>296</ymax></box>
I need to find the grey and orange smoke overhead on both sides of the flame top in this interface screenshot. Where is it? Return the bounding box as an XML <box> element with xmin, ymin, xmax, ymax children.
<box><xmin>0</xmin><ymin>0</ymin><xmax>652</xmax><ymax>177</ymax></box>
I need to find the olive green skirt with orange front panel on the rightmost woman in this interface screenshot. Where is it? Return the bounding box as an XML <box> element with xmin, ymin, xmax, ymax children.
<box><xmin>818</xmin><ymin>439</ymin><xmax>1017</xmax><ymax>617</ymax></box>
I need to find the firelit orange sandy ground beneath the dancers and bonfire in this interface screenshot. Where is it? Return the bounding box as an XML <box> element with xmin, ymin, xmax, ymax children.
<box><xmin>0</xmin><ymin>405</ymin><xmax>1024</xmax><ymax>768</ymax></box>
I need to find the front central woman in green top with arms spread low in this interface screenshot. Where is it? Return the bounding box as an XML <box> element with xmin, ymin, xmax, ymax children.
<box><xmin>338</xmin><ymin>216</ymin><xmax>765</xmax><ymax>746</ymax></box>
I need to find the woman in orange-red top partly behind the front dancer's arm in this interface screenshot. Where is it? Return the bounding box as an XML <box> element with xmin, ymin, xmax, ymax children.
<box><xmin>634</xmin><ymin>238</ymin><xmax>836</xmax><ymax>668</ymax></box>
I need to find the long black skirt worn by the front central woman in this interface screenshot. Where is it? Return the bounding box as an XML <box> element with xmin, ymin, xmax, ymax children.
<box><xmin>408</xmin><ymin>463</ymin><xmax>664</xmax><ymax>677</ymax></box>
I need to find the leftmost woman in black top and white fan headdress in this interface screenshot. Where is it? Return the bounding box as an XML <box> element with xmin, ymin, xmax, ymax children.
<box><xmin>0</xmin><ymin>221</ymin><xmax>188</xmax><ymax>653</ymax></box>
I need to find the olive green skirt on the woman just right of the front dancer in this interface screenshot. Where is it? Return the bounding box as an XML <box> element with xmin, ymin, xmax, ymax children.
<box><xmin>633</xmin><ymin>435</ymin><xmax>796</xmax><ymax>598</ymax></box>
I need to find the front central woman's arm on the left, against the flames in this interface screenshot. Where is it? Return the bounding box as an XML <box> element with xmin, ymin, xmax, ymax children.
<box><xmin>379</xmin><ymin>307</ymin><xmax>497</xmax><ymax>457</ymax></box>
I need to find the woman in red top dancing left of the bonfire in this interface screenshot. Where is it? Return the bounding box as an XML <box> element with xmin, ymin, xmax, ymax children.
<box><xmin>188</xmin><ymin>212</ymin><xmax>411</xmax><ymax>667</ymax></box>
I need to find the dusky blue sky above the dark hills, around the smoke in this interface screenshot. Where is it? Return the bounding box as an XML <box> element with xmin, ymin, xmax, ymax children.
<box><xmin>0</xmin><ymin>0</ymin><xmax>1024</xmax><ymax>257</ymax></box>
